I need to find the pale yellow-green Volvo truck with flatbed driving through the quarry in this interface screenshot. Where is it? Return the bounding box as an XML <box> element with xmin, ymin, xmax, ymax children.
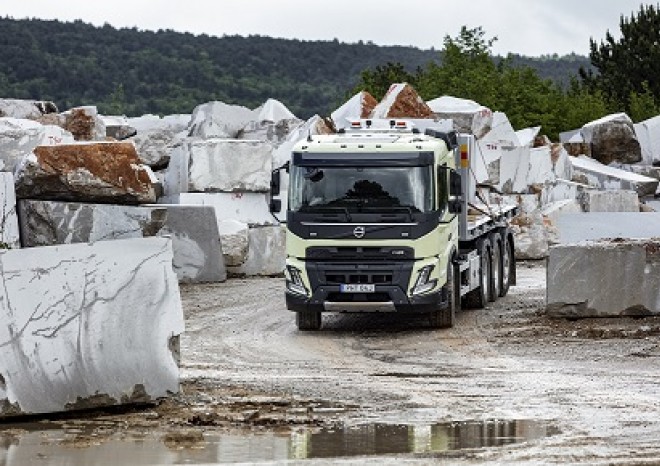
<box><xmin>271</xmin><ymin>119</ymin><xmax>516</xmax><ymax>330</ymax></box>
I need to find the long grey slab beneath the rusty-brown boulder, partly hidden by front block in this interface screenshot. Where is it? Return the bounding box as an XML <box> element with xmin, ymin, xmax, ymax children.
<box><xmin>19</xmin><ymin>200</ymin><xmax>227</xmax><ymax>283</ymax></box>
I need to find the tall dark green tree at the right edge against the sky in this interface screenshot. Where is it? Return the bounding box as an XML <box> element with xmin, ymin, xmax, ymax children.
<box><xmin>580</xmin><ymin>5</ymin><xmax>660</xmax><ymax>113</ymax></box>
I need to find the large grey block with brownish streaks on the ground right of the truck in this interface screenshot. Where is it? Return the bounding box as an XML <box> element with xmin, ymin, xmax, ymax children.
<box><xmin>546</xmin><ymin>238</ymin><xmax>660</xmax><ymax>318</ymax></box>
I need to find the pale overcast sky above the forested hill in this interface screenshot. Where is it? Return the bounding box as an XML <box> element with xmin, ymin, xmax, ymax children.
<box><xmin>0</xmin><ymin>0</ymin><xmax>656</xmax><ymax>56</ymax></box>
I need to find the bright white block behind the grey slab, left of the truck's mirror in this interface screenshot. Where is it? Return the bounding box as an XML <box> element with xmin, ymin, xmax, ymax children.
<box><xmin>159</xmin><ymin>193</ymin><xmax>279</xmax><ymax>226</ymax></box>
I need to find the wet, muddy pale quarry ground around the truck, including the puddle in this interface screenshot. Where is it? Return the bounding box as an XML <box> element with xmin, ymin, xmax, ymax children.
<box><xmin>0</xmin><ymin>263</ymin><xmax>660</xmax><ymax>465</ymax></box>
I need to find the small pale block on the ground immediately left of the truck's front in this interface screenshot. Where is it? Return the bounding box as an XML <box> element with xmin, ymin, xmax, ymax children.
<box><xmin>228</xmin><ymin>226</ymin><xmax>286</xmax><ymax>276</ymax></box>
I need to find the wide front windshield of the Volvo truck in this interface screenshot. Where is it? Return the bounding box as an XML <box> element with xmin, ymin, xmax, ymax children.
<box><xmin>289</xmin><ymin>166</ymin><xmax>433</xmax><ymax>212</ymax></box>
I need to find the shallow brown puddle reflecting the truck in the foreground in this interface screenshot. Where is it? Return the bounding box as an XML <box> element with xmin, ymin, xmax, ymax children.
<box><xmin>0</xmin><ymin>421</ymin><xmax>558</xmax><ymax>466</ymax></box>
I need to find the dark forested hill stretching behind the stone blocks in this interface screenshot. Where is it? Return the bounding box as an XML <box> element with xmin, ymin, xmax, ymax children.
<box><xmin>0</xmin><ymin>18</ymin><xmax>588</xmax><ymax>118</ymax></box>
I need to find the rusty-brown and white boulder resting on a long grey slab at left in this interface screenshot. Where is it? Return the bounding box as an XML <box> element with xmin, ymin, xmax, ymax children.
<box><xmin>16</xmin><ymin>142</ymin><xmax>156</xmax><ymax>204</ymax></box>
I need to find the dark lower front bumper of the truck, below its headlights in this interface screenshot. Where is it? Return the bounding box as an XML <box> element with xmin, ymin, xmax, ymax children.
<box><xmin>286</xmin><ymin>285</ymin><xmax>446</xmax><ymax>313</ymax></box>
